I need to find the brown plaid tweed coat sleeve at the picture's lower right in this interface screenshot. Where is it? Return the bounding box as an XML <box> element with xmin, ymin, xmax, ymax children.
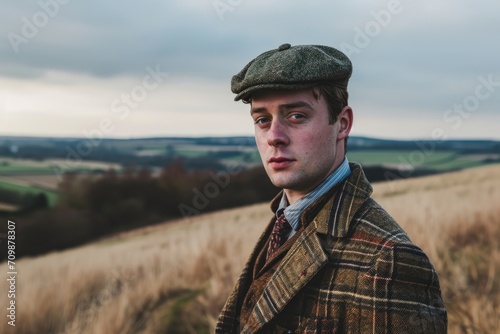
<box><xmin>364</xmin><ymin>244</ymin><xmax>447</xmax><ymax>334</ymax></box>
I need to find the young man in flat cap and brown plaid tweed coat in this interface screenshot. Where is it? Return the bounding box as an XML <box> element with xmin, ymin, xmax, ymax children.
<box><xmin>216</xmin><ymin>44</ymin><xmax>447</xmax><ymax>333</ymax></box>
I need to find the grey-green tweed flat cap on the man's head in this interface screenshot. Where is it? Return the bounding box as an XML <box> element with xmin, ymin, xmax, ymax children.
<box><xmin>231</xmin><ymin>44</ymin><xmax>352</xmax><ymax>101</ymax></box>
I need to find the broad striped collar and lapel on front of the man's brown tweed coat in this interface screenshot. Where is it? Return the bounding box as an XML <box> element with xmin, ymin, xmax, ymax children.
<box><xmin>241</xmin><ymin>163</ymin><xmax>372</xmax><ymax>333</ymax></box>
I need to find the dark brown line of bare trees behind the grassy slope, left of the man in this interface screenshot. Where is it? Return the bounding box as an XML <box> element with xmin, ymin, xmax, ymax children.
<box><xmin>0</xmin><ymin>159</ymin><xmax>279</xmax><ymax>259</ymax></box>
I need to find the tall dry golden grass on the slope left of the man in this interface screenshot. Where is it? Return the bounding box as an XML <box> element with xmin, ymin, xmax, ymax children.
<box><xmin>0</xmin><ymin>205</ymin><xmax>269</xmax><ymax>333</ymax></box>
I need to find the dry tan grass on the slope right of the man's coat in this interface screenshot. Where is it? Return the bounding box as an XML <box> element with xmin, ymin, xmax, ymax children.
<box><xmin>375</xmin><ymin>165</ymin><xmax>500</xmax><ymax>333</ymax></box>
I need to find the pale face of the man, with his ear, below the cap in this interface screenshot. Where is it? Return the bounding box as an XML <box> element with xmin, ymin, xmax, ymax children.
<box><xmin>251</xmin><ymin>89</ymin><xmax>352</xmax><ymax>203</ymax></box>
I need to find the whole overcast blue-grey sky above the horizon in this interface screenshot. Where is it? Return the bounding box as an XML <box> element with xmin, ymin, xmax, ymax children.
<box><xmin>0</xmin><ymin>0</ymin><xmax>500</xmax><ymax>140</ymax></box>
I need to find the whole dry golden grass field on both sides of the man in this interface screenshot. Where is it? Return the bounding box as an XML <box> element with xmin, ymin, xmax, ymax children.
<box><xmin>0</xmin><ymin>165</ymin><xmax>500</xmax><ymax>334</ymax></box>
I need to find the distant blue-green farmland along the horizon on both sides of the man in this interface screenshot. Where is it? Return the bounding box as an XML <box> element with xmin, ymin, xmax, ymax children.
<box><xmin>0</xmin><ymin>137</ymin><xmax>500</xmax><ymax>211</ymax></box>
